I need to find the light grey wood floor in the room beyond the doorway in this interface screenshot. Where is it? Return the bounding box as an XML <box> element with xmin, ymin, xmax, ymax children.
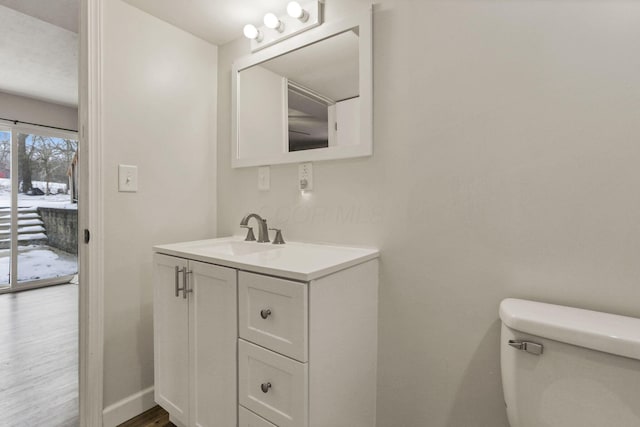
<box><xmin>0</xmin><ymin>285</ymin><xmax>78</xmax><ymax>427</ymax></box>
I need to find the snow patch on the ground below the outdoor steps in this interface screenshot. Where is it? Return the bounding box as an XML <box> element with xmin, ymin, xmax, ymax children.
<box><xmin>0</xmin><ymin>245</ymin><xmax>78</xmax><ymax>284</ymax></box>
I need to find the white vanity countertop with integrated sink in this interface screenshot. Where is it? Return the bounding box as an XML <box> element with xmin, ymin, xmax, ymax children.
<box><xmin>153</xmin><ymin>236</ymin><xmax>380</xmax><ymax>282</ymax></box>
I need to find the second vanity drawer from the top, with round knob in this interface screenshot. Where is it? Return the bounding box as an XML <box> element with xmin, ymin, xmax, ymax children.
<box><xmin>238</xmin><ymin>340</ymin><xmax>308</xmax><ymax>427</ymax></box>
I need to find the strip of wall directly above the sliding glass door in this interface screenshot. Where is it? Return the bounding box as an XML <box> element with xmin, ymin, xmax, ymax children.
<box><xmin>0</xmin><ymin>92</ymin><xmax>78</xmax><ymax>130</ymax></box>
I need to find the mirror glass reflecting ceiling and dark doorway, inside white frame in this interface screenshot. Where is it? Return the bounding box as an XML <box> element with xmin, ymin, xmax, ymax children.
<box><xmin>240</xmin><ymin>30</ymin><xmax>359</xmax><ymax>153</ymax></box>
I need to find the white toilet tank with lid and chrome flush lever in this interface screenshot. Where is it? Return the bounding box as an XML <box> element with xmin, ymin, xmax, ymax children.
<box><xmin>500</xmin><ymin>299</ymin><xmax>640</xmax><ymax>427</ymax></box>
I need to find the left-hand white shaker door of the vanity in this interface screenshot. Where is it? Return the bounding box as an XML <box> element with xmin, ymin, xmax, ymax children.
<box><xmin>153</xmin><ymin>254</ymin><xmax>189</xmax><ymax>425</ymax></box>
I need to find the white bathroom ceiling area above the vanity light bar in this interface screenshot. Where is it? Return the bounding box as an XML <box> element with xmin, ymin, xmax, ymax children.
<box><xmin>124</xmin><ymin>0</ymin><xmax>288</xmax><ymax>45</ymax></box>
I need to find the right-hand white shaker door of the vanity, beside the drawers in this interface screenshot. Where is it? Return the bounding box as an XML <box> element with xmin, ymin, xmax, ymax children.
<box><xmin>188</xmin><ymin>261</ymin><xmax>238</xmax><ymax>427</ymax></box>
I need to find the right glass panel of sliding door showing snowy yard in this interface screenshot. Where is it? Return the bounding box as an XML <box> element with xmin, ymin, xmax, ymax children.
<box><xmin>16</xmin><ymin>132</ymin><xmax>78</xmax><ymax>286</ymax></box>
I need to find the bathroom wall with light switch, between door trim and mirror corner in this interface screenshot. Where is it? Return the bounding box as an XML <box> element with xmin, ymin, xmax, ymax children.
<box><xmin>103</xmin><ymin>0</ymin><xmax>217</xmax><ymax>421</ymax></box>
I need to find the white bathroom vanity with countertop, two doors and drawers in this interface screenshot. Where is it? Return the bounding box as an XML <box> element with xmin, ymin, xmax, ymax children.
<box><xmin>153</xmin><ymin>238</ymin><xmax>378</xmax><ymax>427</ymax></box>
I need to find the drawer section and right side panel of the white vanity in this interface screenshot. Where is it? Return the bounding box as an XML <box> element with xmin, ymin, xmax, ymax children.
<box><xmin>238</xmin><ymin>260</ymin><xmax>378</xmax><ymax>427</ymax></box>
